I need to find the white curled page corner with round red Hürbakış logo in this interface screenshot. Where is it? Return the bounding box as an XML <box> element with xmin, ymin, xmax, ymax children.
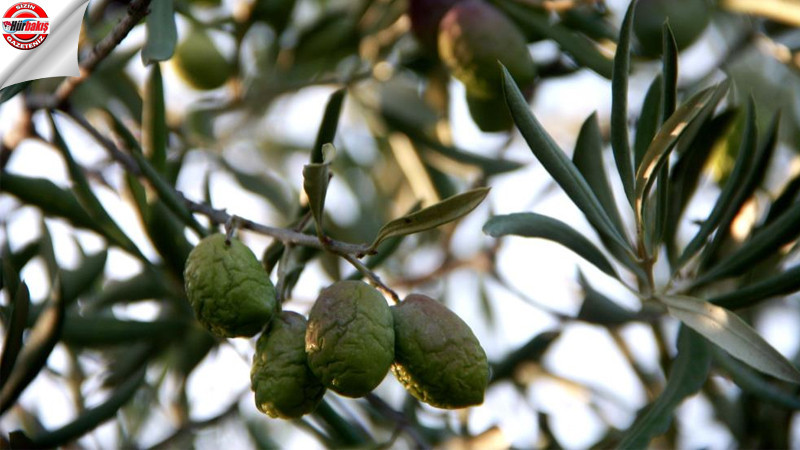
<box><xmin>0</xmin><ymin>0</ymin><xmax>89</xmax><ymax>88</ymax></box>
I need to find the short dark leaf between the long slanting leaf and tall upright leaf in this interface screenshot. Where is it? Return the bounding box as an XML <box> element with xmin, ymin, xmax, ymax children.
<box><xmin>572</xmin><ymin>113</ymin><xmax>625</xmax><ymax>235</ymax></box>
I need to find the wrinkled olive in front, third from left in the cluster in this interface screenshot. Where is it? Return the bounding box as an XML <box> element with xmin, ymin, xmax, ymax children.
<box><xmin>306</xmin><ymin>280</ymin><xmax>394</xmax><ymax>397</ymax></box>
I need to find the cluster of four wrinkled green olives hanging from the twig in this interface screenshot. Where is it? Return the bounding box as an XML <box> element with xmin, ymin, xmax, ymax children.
<box><xmin>185</xmin><ymin>234</ymin><xmax>489</xmax><ymax>419</ymax></box>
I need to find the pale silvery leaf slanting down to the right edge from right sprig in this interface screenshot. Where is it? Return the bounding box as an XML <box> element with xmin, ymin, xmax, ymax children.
<box><xmin>657</xmin><ymin>295</ymin><xmax>800</xmax><ymax>384</ymax></box>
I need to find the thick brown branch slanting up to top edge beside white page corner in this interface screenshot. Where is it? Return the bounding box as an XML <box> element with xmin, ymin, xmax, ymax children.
<box><xmin>28</xmin><ymin>0</ymin><xmax>151</xmax><ymax>109</ymax></box>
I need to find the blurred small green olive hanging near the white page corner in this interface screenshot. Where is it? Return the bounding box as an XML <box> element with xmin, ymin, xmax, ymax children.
<box><xmin>172</xmin><ymin>27</ymin><xmax>233</xmax><ymax>90</ymax></box>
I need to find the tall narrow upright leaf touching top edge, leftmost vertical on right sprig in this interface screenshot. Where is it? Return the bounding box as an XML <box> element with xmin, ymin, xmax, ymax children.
<box><xmin>611</xmin><ymin>1</ymin><xmax>636</xmax><ymax>203</ymax></box>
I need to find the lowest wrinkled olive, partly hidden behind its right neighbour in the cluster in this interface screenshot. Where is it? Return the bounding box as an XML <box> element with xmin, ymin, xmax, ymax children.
<box><xmin>250</xmin><ymin>311</ymin><xmax>325</xmax><ymax>419</ymax></box>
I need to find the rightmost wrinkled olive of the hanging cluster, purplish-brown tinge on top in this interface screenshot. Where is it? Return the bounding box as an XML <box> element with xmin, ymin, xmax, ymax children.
<box><xmin>391</xmin><ymin>294</ymin><xmax>489</xmax><ymax>409</ymax></box>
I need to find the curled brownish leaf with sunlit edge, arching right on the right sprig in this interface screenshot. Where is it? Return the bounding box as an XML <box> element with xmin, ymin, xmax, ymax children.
<box><xmin>634</xmin><ymin>82</ymin><xmax>728</xmax><ymax>223</ymax></box>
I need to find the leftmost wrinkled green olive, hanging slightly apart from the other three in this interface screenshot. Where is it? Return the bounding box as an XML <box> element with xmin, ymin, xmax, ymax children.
<box><xmin>184</xmin><ymin>234</ymin><xmax>276</xmax><ymax>337</ymax></box>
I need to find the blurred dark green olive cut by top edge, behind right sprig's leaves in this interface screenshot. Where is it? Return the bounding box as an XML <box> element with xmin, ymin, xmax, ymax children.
<box><xmin>633</xmin><ymin>0</ymin><xmax>711</xmax><ymax>56</ymax></box>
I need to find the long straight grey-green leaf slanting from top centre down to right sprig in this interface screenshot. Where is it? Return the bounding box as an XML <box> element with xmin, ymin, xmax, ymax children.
<box><xmin>503</xmin><ymin>67</ymin><xmax>630</xmax><ymax>252</ymax></box>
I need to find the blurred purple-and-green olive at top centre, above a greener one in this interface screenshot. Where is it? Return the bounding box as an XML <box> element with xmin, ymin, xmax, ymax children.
<box><xmin>439</xmin><ymin>0</ymin><xmax>536</xmax><ymax>98</ymax></box>
